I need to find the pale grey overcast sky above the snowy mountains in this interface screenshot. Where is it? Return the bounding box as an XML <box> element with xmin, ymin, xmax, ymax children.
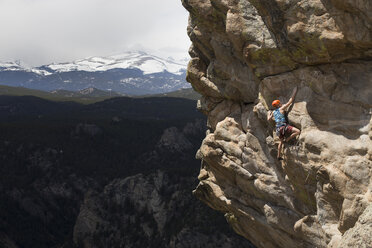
<box><xmin>0</xmin><ymin>0</ymin><xmax>190</xmax><ymax>66</ymax></box>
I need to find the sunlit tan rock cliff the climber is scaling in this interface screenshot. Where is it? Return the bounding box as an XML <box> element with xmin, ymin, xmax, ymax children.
<box><xmin>182</xmin><ymin>0</ymin><xmax>372</xmax><ymax>248</ymax></box>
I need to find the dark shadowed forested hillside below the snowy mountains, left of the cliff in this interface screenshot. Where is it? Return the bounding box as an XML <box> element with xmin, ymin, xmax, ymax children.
<box><xmin>0</xmin><ymin>96</ymin><xmax>254</xmax><ymax>248</ymax></box>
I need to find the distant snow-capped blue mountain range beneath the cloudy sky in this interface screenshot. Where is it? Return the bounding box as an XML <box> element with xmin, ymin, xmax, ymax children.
<box><xmin>0</xmin><ymin>52</ymin><xmax>190</xmax><ymax>95</ymax></box>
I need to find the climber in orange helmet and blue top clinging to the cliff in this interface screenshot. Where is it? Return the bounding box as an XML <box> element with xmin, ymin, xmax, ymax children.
<box><xmin>267</xmin><ymin>87</ymin><xmax>300</xmax><ymax>160</ymax></box>
